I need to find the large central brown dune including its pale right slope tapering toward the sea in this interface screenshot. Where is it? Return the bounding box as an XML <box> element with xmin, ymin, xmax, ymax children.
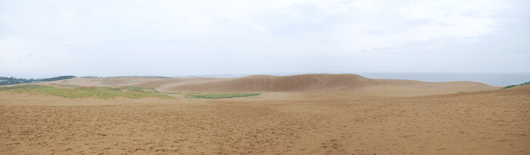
<box><xmin>158</xmin><ymin>74</ymin><xmax>500</xmax><ymax>97</ymax></box>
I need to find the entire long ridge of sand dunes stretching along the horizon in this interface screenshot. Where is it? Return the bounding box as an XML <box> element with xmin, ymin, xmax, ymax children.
<box><xmin>37</xmin><ymin>74</ymin><xmax>500</xmax><ymax>97</ymax></box>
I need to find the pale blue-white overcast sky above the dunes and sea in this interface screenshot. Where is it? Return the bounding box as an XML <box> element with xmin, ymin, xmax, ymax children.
<box><xmin>0</xmin><ymin>0</ymin><xmax>530</xmax><ymax>78</ymax></box>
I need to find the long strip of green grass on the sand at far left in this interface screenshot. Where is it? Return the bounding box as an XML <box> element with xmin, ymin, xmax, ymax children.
<box><xmin>0</xmin><ymin>85</ymin><xmax>173</xmax><ymax>99</ymax></box>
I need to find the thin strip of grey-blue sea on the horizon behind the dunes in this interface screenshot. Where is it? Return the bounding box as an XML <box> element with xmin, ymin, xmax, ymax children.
<box><xmin>177</xmin><ymin>72</ymin><xmax>530</xmax><ymax>87</ymax></box>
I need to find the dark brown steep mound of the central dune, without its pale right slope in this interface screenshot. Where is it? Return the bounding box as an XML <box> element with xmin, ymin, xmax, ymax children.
<box><xmin>165</xmin><ymin>74</ymin><xmax>376</xmax><ymax>92</ymax></box>
